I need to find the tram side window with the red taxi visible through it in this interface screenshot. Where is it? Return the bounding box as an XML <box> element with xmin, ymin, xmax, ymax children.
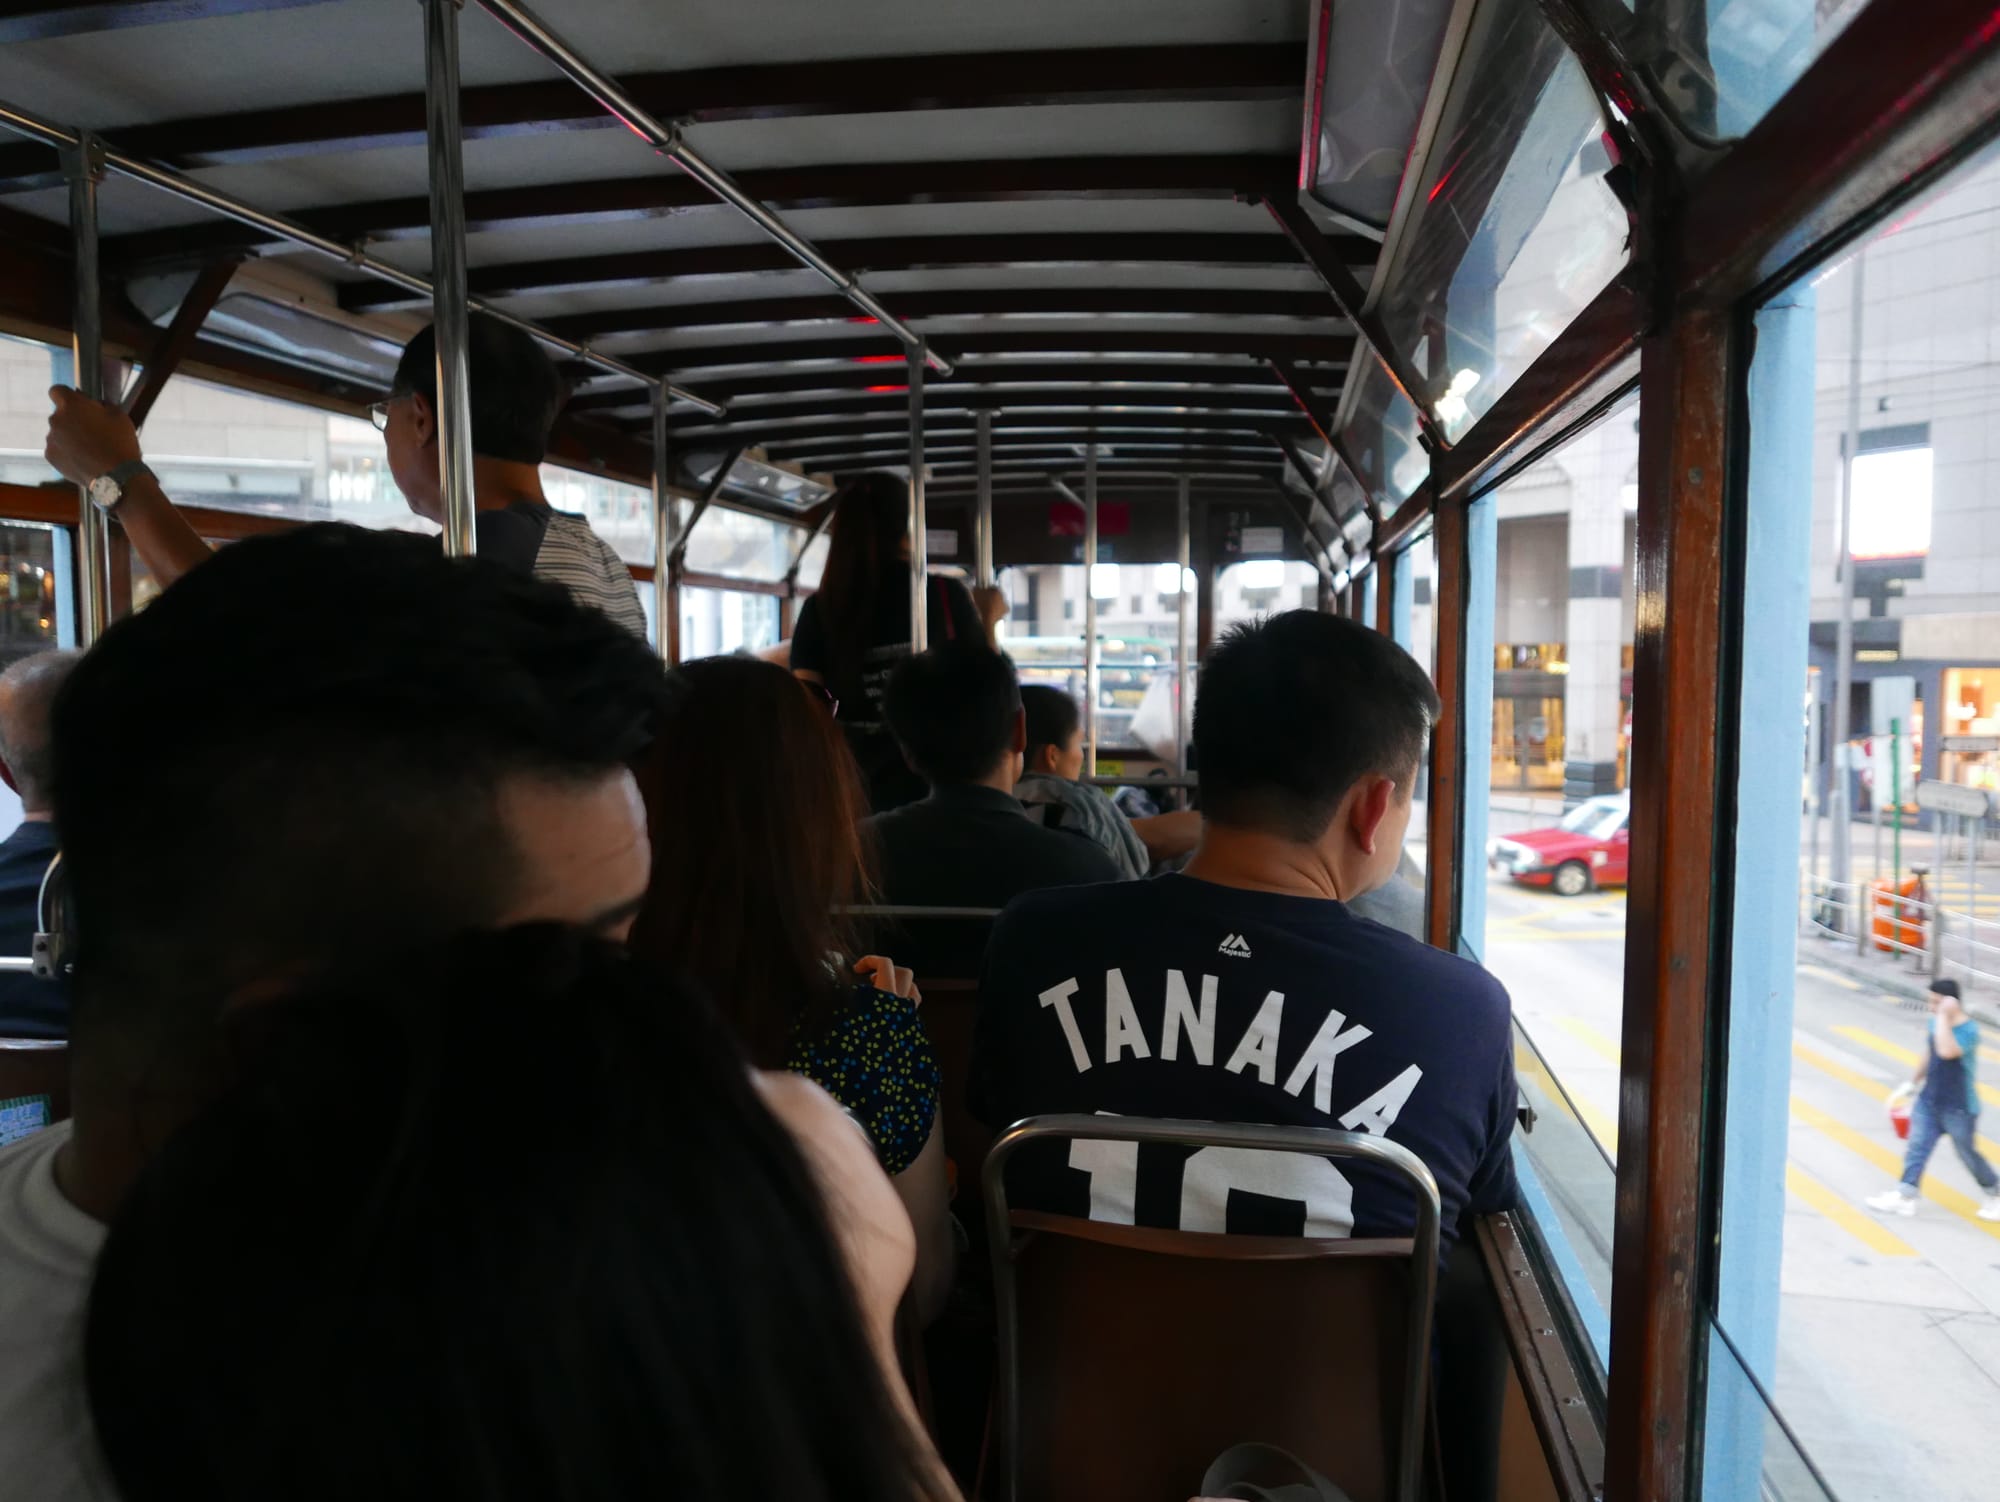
<box><xmin>1460</xmin><ymin>398</ymin><xmax>1638</xmax><ymax>1360</ymax></box>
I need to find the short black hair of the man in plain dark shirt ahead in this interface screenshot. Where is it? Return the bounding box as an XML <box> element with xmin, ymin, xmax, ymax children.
<box><xmin>882</xmin><ymin>642</ymin><xmax>1020</xmax><ymax>784</ymax></box>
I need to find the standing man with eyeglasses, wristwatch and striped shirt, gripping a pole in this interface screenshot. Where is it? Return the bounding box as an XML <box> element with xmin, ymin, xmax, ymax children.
<box><xmin>46</xmin><ymin>314</ymin><xmax>646</xmax><ymax>636</ymax></box>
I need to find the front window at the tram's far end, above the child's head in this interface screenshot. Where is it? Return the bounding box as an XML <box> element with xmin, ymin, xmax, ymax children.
<box><xmin>996</xmin><ymin>562</ymin><xmax>1192</xmax><ymax>776</ymax></box>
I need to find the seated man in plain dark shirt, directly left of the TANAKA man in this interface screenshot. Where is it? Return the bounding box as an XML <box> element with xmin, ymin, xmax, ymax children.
<box><xmin>866</xmin><ymin>644</ymin><xmax>1120</xmax><ymax>976</ymax></box>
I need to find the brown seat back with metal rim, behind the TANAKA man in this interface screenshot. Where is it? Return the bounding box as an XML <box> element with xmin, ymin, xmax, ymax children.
<box><xmin>986</xmin><ymin>1116</ymin><xmax>1438</xmax><ymax>1502</ymax></box>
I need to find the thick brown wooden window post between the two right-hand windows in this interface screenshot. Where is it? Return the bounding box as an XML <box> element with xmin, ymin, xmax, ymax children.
<box><xmin>1604</xmin><ymin>308</ymin><xmax>1736</xmax><ymax>1502</ymax></box>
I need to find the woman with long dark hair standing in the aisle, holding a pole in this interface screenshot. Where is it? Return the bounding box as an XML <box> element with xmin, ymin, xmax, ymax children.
<box><xmin>790</xmin><ymin>474</ymin><xmax>992</xmax><ymax>814</ymax></box>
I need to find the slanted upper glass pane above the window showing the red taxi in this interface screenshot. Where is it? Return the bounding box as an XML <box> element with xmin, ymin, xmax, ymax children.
<box><xmin>1378</xmin><ymin>25</ymin><xmax>1628</xmax><ymax>440</ymax></box>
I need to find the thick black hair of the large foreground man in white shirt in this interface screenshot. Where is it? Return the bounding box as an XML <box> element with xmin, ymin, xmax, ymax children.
<box><xmin>54</xmin><ymin>524</ymin><xmax>662</xmax><ymax>1068</ymax></box>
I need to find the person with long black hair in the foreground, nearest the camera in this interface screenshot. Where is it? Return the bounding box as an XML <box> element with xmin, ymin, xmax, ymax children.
<box><xmin>80</xmin><ymin>928</ymin><xmax>954</xmax><ymax>1502</ymax></box>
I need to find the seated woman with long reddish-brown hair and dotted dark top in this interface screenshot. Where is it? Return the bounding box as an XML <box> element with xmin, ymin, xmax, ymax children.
<box><xmin>632</xmin><ymin>658</ymin><xmax>952</xmax><ymax>1320</ymax></box>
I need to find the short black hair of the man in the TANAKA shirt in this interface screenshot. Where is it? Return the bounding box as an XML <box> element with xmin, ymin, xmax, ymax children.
<box><xmin>1194</xmin><ymin>610</ymin><xmax>1438</xmax><ymax>844</ymax></box>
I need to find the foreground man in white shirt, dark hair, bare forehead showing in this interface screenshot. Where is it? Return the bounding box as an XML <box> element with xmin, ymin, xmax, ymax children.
<box><xmin>0</xmin><ymin>526</ymin><xmax>662</xmax><ymax>1502</ymax></box>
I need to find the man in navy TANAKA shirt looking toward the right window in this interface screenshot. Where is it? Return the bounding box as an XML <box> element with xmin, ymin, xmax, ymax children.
<box><xmin>972</xmin><ymin>610</ymin><xmax>1516</xmax><ymax>1242</ymax></box>
